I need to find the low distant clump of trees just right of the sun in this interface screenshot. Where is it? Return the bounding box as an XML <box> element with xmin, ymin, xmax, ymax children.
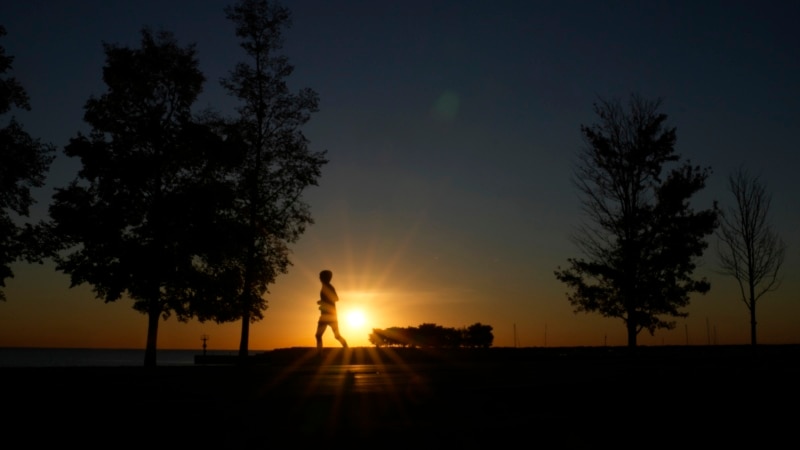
<box><xmin>369</xmin><ymin>322</ymin><xmax>494</xmax><ymax>348</ymax></box>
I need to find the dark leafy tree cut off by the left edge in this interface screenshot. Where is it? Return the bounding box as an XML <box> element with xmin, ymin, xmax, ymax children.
<box><xmin>0</xmin><ymin>26</ymin><xmax>54</xmax><ymax>301</ymax></box>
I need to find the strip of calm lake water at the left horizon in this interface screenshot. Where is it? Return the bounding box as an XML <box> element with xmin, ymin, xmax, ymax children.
<box><xmin>0</xmin><ymin>347</ymin><xmax>245</xmax><ymax>367</ymax></box>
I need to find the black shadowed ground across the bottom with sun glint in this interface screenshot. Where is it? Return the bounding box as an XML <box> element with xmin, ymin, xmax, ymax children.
<box><xmin>0</xmin><ymin>346</ymin><xmax>800</xmax><ymax>449</ymax></box>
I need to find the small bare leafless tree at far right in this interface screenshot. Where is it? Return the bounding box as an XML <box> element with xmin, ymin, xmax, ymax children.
<box><xmin>718</xmin><ymin>169</ymin><xmax>786</xmax><ymax>345</ymax></box>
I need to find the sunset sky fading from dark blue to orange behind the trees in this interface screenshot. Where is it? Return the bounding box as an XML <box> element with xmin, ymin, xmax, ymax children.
<box><xmin>0</xmin><ymin>0</ymin><xmax>800</xmax><ymax>349</ymax></box>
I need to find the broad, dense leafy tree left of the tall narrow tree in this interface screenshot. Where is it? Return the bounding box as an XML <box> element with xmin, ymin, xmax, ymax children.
<box><xmin>50</xmin><ymin>30</ymin><xmax>216</xmax><ymax>366</ymax></box>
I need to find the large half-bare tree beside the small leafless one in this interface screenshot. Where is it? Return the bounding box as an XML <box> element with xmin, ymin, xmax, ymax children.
<box><xmin>555</xmin><ymin>95</ymin><xmax>717</xmax><ymax>347</ymax></box>
